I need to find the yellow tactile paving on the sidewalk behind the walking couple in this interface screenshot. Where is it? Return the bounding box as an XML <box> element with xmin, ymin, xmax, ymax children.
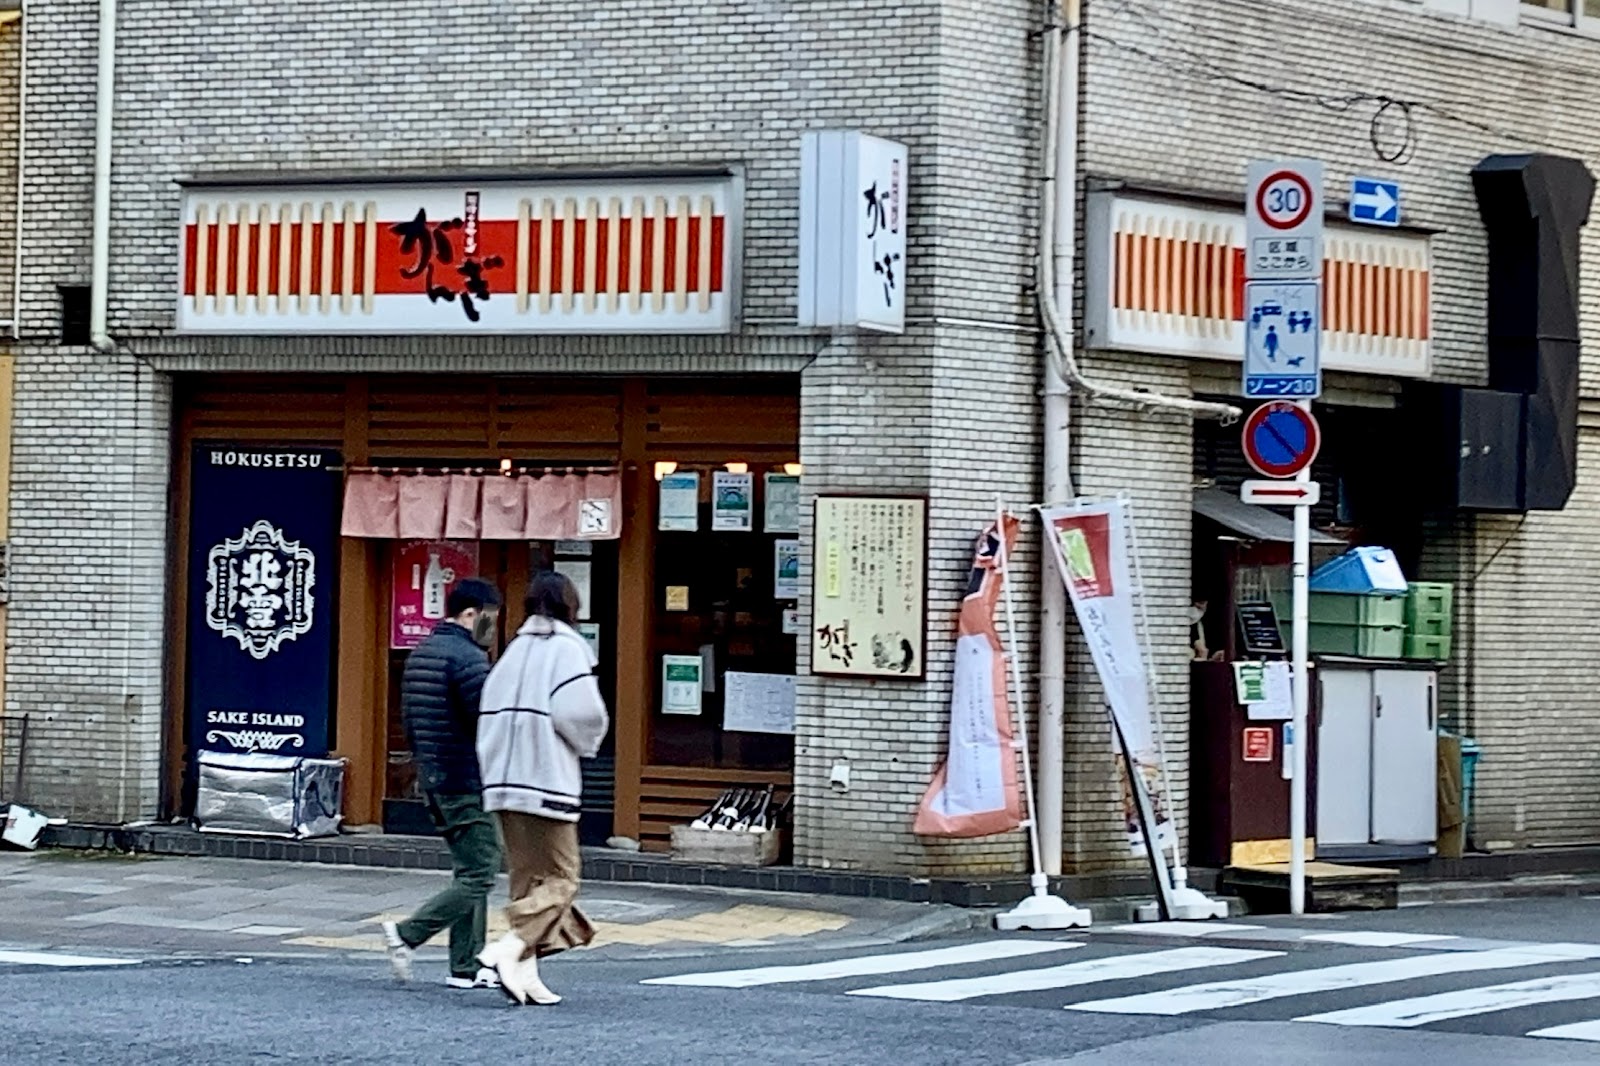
<box><xmin>285</xmin><ymin>903</ymin><xmax>850</xmax><ymax>951</ymax></box>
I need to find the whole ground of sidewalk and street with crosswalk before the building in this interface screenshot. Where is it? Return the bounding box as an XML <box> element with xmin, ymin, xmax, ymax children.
<box><xmin>9</xmin><ymin>856</ymin><xmax>1600</xmax><ymax>1066</ymax></box>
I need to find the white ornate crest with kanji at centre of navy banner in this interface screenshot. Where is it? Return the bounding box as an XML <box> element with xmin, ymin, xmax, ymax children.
<box><xmin>205</xmin><ymin>519</ymin><xmax>317</xmax><ymax>659</ymax></box>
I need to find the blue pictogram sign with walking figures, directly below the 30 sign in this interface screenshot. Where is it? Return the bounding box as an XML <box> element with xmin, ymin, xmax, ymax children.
<box><xmin>1245</xmin><ymin>282</ymin><xmax>1322</xmax><ymax>400</ymax></box>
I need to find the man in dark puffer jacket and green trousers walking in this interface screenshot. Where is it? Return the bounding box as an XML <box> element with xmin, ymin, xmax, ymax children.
<box><xmin>384</xmin><ymin>578</ymin><xmax>501</xmax><ymax>988</ymax></box>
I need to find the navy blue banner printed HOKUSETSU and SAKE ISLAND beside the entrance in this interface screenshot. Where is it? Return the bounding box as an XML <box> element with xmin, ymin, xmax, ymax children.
<box><xmin>187</xmin><ymin>445</ymin><xmax>344</xmax><ymax>755</ymax></box>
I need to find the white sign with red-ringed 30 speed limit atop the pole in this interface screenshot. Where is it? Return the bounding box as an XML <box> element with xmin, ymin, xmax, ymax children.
<box><xmin>1245</xmin><ymin>158</ymin><xmax>1325</xmax><ymax>280</ymax></box>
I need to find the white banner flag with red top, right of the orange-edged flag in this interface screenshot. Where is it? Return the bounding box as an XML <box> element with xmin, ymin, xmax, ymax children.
<box><xmin>1040</xmin><ymin>499</ymin><xmax>1173</xmax><ymax>848</ymax></box>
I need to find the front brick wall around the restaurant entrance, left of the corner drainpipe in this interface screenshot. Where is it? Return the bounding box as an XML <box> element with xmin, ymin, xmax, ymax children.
<box><xmin>9</xmin><ymin>0</ymin><xmax>1037</xmax><ymax>869</ymax></box>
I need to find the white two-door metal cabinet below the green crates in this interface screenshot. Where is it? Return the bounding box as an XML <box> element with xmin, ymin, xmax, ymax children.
<box><xmin>1315</xmin><ymin>663</ymin><xmax>1438</xmax><ymax>848</ymax></box>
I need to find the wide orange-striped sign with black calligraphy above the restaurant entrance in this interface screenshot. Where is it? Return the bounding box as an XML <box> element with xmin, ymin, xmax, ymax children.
<box><xmin>178</xmin><ymin>179</ymin><xmax>738</xmax><ymax>335</ymax></box>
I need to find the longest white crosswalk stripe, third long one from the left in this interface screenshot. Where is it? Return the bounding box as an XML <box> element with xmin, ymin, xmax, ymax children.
<box><xmin>1067</xmin><ymin>944</ymin><xmax>1600</xmax><ymax>1015</ymax></box>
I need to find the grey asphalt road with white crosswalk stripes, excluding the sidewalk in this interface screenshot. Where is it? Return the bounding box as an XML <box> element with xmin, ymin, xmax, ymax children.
<box><xmin>9</xmin><ymin>928</ymin><xmax>1600</xmax><ymax>1066</ymax></box>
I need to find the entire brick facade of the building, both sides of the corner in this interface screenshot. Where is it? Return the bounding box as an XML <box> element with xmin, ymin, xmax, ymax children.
<box><xmin>0</xmin><ymin>0</ymin><xmax>1600</xmax><ymax>874</ymax></box>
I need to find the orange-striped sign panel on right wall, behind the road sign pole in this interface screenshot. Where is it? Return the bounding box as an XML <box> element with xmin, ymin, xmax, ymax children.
<box><xmin>1085</xmin><ymin>194</ymin><xmax>1432</xmax><ymax>378</ymax></box>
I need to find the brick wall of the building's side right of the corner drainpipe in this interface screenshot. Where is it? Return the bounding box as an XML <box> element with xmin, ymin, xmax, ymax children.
<box><xmin>1077</xmin><ymin>0</ymin><xmax>1600</xmax><ymax>855</ymax></box>
